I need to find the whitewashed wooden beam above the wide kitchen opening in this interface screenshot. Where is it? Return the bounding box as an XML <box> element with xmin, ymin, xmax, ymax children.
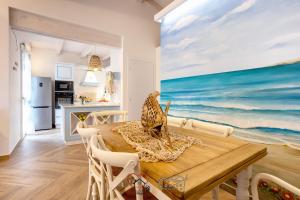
<box><xmin>9</xmin><ymin>8</ymin><xmax>122</xmax><ymax>48</ymax></box>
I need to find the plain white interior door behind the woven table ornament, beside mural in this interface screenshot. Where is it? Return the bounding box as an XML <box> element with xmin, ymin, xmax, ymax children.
<box><xmin>128</xmin><ymin>59</ymin><xmax>155</xmax><ymax>120</ymax></box>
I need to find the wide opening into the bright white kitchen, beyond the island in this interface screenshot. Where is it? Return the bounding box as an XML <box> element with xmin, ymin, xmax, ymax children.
<box><xmin>12</xmin><ymin>29</ymin><xmax>122</xmax><ymax>139</ymax></box>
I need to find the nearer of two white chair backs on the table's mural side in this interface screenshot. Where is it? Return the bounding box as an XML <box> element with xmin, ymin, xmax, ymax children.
<box><xmin>184</xmin><ymin>119</ymin><xmax>234</xmax><ymax>137</ymax></box>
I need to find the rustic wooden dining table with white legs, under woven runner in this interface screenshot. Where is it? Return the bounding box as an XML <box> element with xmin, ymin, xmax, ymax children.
<box><xmin>98</xmin><ymin>122</ymin><xmax>267</xmax><ymax>200</ymax></box>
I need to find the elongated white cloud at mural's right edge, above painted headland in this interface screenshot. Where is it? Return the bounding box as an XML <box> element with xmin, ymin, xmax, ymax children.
<box><xmin>265</xmin><ymin>33</ymin><xmax>300</xmax><ymax>48</ymax></box>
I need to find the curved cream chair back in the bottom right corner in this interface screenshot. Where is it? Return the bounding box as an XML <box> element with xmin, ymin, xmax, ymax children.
<box><xmin>251</xmin><ymin>173</ymin><xmax>300</xmax><ymax>200</ymax></box>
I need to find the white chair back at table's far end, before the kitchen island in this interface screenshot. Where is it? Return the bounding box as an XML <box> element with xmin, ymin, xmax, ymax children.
<box><xmin>91</xmin><ymin>110</ymin><xmax>128</xmax><ymax>125</ymax></box>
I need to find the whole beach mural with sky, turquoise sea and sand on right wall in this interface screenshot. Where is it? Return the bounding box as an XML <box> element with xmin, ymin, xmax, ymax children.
<box><xmin>160</xmin><ymin>0</ymin><xmax>300</xmax><ymax>188</ymax></box>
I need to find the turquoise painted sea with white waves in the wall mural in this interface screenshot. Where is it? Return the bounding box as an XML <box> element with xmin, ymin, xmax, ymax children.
<box><xmin>161</xmin><ymin>62</ymin><xmax>300</xmax><ymax>147</ymax></box>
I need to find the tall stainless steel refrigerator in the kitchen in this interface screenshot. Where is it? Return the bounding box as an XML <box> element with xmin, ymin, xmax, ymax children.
<box><xmin>31</xmin><ymin>76</ymin><xmax>52</xmax><ymax>130</ymax></box>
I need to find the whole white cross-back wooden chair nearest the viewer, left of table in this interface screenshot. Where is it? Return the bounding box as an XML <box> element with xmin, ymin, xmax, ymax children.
<box><xmin>91</xmin><ymin>136</ymin><xmax>159</xmax><ymax>200</ymax></box>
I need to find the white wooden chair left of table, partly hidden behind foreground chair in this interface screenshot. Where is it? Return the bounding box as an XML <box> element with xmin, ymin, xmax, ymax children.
<box><xmin>76</xmin><ymin>121</ymin><xmax>98</xmax><ymax>200</ymax></box>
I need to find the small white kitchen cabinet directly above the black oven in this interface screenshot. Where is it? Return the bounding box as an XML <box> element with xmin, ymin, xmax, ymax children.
<box><xmin>55</xmin><ymin>63</ymin><xmax>74</xmax><ymax>81</ymax></box>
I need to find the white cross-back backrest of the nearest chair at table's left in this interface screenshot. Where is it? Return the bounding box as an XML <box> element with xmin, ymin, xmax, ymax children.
<box><xmin>91</xmin><ymin>135</ymin><xmax>142</xmax><ymax>199</ymax></box>
